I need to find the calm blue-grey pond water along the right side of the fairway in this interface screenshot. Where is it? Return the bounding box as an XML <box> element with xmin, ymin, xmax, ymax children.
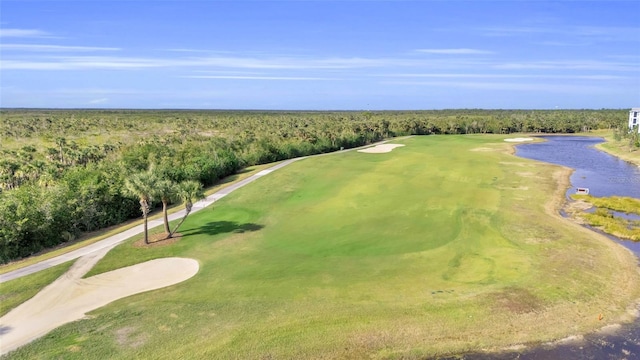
<box><xmin>451</xmin><ymin>136</ymin><xmax>640</xmax><ymax>360</ymax></box>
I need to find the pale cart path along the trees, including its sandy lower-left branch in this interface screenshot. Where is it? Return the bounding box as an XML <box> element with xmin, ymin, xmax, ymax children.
<box><xmin>0</xmin><ymin>140</ymin><xmax>410</xmax><ymax>355</ymax></box>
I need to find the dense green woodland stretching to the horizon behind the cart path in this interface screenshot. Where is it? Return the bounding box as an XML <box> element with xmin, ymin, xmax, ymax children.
<box><xmin>0</xmin><ymin>109</ymin><xmax>627</xmax><ymax>262</ymax></box>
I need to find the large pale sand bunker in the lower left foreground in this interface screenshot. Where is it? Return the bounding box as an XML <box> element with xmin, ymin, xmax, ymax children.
<box><xmin>0</xmin><ymin>258</ymin><xmax>199</xmax><ymax>354</ymax></box>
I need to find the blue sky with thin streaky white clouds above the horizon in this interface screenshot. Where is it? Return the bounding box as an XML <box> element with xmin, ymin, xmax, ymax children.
<box><xmin>0</xmin><ymin>0</ymin><xmax>640</xmax><ymax>110</ymax></box>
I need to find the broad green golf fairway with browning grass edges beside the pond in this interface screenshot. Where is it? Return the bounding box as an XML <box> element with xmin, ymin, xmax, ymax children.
<box><xmin>6</xmin><ymin>135</ymin><xmax>640</xmax><ymax>359</ymax></box>
